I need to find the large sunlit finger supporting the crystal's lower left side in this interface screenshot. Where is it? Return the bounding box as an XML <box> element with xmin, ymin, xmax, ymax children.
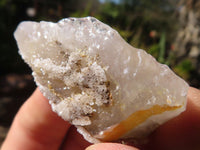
<box><xmin>2</xmin><ymin>89</ymin><xmax>70</xmax><ymax>150</ymax></box>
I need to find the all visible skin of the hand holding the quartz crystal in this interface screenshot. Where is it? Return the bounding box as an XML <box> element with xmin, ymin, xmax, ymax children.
<box><xmin>1</xmin><ymin>87</ymin><xmax>200</xmax><ymax>150</ymax></box>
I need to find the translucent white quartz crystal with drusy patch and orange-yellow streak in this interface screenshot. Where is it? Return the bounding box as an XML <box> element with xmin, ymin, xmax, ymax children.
<box><xmin>14</xmin><ymin>17</ymin><xmax>188</xmax><ymax>143</ymax></box>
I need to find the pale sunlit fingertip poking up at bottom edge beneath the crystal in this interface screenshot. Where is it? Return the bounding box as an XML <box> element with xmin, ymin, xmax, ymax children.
<box><xmin>86</xmin><ymin>143</ymin><xmax>139</xmax><ymax>150</ymax></box>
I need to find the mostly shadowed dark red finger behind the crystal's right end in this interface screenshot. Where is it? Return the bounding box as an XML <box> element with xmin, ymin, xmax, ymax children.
<box><xmin>143</xmin><ymin>88</ymin><xmax>200</xmax><ymax>150</ymax></box>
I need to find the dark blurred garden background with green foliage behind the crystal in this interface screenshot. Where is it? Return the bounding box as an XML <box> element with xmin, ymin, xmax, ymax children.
<box><xmin>0</xmin><ymin>0</ymin><xmax>200</xmax><ymax>145</ymax></box>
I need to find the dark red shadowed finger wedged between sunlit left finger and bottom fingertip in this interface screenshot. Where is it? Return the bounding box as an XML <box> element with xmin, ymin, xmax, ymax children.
<box><xmin>61</xmin><ymin>126</ymin><xmax>91</xmax><ymax>150</ymax></box>
